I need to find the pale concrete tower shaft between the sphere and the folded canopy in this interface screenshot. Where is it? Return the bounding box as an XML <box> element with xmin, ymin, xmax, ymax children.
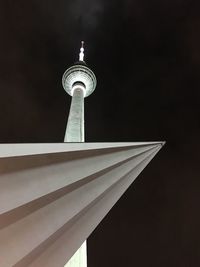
<box><xmin>64</xmin><ymin>87</ymin><xmax>85</xmax><ymax>142</ymax></box>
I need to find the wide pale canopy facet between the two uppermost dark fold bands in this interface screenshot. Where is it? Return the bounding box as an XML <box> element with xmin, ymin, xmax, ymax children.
<box><xmin>0</xmin><ymin>145</ymin><xmax>159</xmax><ymax>214</ymax></box>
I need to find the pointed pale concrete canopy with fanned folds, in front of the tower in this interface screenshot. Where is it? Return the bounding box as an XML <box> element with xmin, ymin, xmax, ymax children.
<box><xmin>0</xmin><ymin>142</ymin><xmax>163</xmax><ymax>267</ymax></box>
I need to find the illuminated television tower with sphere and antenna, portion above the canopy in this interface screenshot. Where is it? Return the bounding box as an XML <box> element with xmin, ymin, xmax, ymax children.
<box><xmin>62</xmin><ymin>41</ymin><xmax>97</xmax><ymax>142</ymax></box>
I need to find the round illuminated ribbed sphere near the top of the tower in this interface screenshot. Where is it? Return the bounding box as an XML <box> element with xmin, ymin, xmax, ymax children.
<box><xmin>62</xmin><ymin>65</ymin><xmax>97</xmax><ymax>97</ymax></box>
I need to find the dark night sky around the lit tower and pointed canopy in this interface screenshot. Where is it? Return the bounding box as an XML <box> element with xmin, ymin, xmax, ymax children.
<box><xmin>0</xmin><ymin>0</ymin><xmax>200</xmax><ymax>267</ymax></box>
